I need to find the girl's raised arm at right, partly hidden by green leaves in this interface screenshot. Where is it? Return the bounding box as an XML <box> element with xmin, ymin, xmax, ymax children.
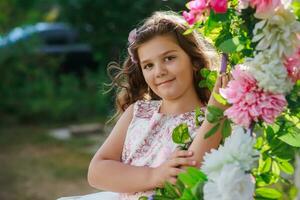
<box><xmin>188</xmin><ymin>76</ymin><xmax>229</xmax><ymax>167</ymax></box>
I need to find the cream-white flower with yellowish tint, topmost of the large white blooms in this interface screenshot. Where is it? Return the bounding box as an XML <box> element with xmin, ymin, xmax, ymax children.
<box><xmin>252</xmin><ymin>8</ymin><xmax>300</xmax><ymax>59</ymax></box>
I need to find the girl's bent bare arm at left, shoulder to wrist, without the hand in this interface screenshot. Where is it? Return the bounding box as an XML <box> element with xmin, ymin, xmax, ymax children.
<box><xmin>88</xmin><ymin>105</ymin><xmax>155</xmax><ymax>192</ymax></box>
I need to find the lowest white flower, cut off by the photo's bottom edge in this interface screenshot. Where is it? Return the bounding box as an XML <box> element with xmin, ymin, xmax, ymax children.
<box><xmin>203</xmin><ymin>164</ymin><xmax>254</xmax><ymax>200</ymax></box>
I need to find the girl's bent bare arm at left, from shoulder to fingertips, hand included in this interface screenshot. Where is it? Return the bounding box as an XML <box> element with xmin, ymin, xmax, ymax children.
<box><xmin>88</xmin><ymin>105</ymin><xmax>196</xmax><ymax>193</ymax></box>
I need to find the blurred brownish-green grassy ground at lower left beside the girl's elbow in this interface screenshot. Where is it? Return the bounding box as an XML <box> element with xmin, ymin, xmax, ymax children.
<box><xmin>0</xmin><ymin>126</ymin><xmax>104</xmax><ymax>200</ymax></box>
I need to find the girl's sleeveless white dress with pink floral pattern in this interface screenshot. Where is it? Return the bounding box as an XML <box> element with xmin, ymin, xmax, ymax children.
<box><xmin>59</xmin><ymin>101</ymin><xmax>204</xmax><ymax>200</ymax></box>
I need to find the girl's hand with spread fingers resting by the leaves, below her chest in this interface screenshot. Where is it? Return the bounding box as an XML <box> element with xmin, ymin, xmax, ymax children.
<box><xmin>153</xmin><ymin>150</ymin><xmax>197</xmax><ymax>188</ymax></box>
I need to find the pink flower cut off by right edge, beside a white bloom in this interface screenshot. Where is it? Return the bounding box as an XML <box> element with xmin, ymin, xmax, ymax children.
<box><xmin>284</xmin><ymin>48</ymin><xmax>300</xmax><ymax>82</ymax></box>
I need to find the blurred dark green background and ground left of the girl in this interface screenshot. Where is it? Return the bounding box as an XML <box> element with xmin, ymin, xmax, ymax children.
<box><xmin>0</xmin><ymin>0</ymin><xmax>186</xmax><ymax>200</ymax></box>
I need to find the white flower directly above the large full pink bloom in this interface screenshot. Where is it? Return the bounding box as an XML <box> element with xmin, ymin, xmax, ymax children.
<box><xmin>241</xmin><ymin>50</ymin><xmax>293</xmax><ymax>94</ymax></box>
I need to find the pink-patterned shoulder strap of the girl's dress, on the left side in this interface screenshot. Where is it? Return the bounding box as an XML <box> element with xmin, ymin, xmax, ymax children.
<box><xmin>133</xmin><ymin>100</ymin><xmax>160</xmax><ymax>118</ymax></box>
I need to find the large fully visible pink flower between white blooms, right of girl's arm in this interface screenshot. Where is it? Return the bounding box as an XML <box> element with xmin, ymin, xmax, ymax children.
<box><xmin>220</xmin><ymin>67</ymin><xmax>287</xmax><ymax>127</ymax></box>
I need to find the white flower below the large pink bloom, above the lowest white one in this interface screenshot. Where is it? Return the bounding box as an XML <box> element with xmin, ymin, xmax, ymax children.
<box><xmin>201</xmin><ymin>126</ymin><xmax>258</xmax><ymax>180</ymax></box>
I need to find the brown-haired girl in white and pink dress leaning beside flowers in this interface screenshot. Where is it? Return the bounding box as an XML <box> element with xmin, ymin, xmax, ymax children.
<box><xmin>57</xmin><ymin>12</ymin><xmax>228</xmax><ymax>200</ymax></box>
